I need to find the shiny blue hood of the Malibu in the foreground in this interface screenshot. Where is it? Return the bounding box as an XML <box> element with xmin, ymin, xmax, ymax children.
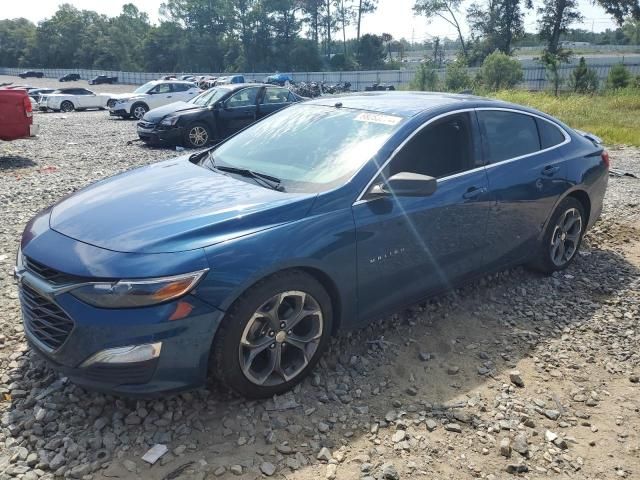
<box><xmin>50</xmin><ymin>157</ymin><xmax>316</xmax><ymax>253</ymax></box>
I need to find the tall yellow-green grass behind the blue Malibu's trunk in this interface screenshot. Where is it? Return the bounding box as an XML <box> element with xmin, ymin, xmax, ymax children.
<box><xmin>490</xmin><ymin>88</ymin><xmax>640</xmax><ymax>147</ymax></box>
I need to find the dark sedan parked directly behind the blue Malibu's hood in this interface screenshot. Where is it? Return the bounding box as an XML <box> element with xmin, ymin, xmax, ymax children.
<box><xmin>138</xmin><ymin>84</ymin><xmax>302</xmax><ymax>148</ymax></box>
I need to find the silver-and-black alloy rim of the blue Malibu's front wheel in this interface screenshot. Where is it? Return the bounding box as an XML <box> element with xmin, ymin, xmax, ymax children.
<box><xmin>238</xmin><ymin>290</ymin><xmax>324</xmax><ymax>386</ymax></box>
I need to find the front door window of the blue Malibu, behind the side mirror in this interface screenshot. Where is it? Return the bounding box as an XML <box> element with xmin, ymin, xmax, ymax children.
<box><xmin>383</xmin><ymin>113</ymin><xmax>477</xmax><ymax>178</ymax></box>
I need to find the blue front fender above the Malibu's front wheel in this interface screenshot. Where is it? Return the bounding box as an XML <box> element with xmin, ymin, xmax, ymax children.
<box><xmin>198</xmin><ymin>209</ymin><xmax>357</xmax><ymax>327</ymax></box>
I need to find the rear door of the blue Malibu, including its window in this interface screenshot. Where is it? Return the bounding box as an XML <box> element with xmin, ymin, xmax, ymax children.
<box><xmin>477</xmin><ymin>109</ymin><xmax>569</xmax><ymax>265</ymax></box>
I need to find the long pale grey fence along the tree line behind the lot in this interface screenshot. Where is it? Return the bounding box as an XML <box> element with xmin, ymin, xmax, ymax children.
<box><xmin>0</xmin><ymin>62</ymin><xmax>640</xmax><ymax>90</ymax></box>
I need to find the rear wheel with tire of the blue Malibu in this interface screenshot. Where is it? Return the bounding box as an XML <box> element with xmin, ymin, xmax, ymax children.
<box><xmin>528</xmin><ymin>197</ymin><xmax>587</xmax><ymax>274</ymax></box>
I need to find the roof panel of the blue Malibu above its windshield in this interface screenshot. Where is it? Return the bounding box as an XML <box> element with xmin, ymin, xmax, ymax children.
<box><xmin>305</xmin><ymin>91</ymin><xmax>528</xmax><ymax>117</ymax></box>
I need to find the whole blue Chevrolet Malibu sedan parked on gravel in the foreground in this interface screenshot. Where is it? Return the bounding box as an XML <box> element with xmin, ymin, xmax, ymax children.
<box><xmin>16</xmin><ymin>92</ymin><xmax>609</xmax><ymax>397</ymax></box>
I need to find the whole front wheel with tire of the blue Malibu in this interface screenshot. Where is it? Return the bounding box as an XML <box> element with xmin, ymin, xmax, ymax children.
<box><xmin>211</xmin><ymin>270</ymin><xmax>333</xmax><ymax>398</ymax></box>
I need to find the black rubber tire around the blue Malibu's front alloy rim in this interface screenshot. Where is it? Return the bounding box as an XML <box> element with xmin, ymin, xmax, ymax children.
<box><xmin>210</xmin><ymin>270</ymin><xmax>333</xmax><ymax>398</ymax></box>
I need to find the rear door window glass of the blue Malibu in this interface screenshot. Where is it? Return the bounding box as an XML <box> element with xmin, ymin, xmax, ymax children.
<box><xmin>478</xmin><ymin>110</ymin><xmax>540</xmax><ymax>163</ymax></box>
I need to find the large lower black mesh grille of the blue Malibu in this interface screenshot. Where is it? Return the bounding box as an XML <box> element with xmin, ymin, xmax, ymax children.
<box><xmin>20</xmin><ymin>284</ymin><xmax>74</xmax><ymax>350</ymax></box>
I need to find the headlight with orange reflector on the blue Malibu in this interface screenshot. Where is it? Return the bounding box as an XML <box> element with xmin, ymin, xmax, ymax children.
<box><xmin>70</xmin><ymin>269</ymin><xmax>208</xmax><ymax>308</ymax></box>
